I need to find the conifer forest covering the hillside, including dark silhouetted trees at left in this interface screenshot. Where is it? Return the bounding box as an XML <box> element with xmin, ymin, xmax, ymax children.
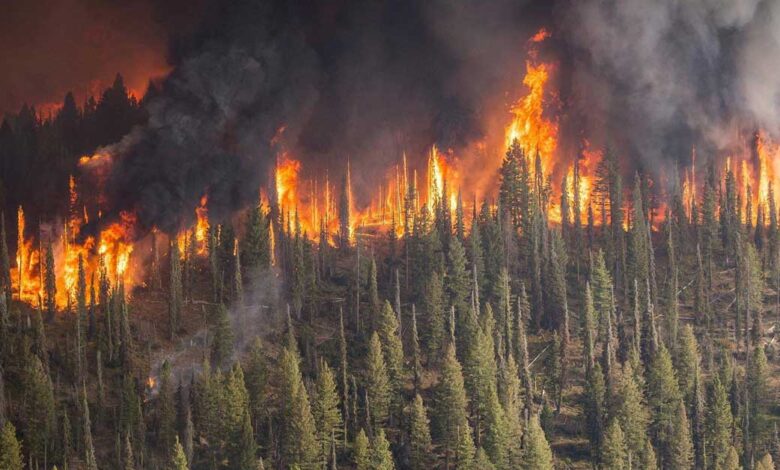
<box><xmin>0</xmin><ymin>77</ymin><xmax>780</xmax><ymax>470</ymax></box>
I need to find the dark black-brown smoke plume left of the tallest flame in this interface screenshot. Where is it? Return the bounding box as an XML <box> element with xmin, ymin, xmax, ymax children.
<box><xmin>97</xmin><ymin>0</ymin><xmax>540</xmax><ymax>230</ymax></box>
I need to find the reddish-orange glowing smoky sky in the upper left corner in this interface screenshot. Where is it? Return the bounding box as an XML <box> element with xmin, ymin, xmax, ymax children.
<box><xmin>0</xmin><ymin>0</ymin><xmax>201</xmax><ymax>115</ymax></box>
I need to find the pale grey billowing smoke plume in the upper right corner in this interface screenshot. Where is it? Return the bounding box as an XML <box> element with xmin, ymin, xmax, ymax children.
<box><xmin>557</xmin><ymin>0</ymin><xmax>780</xmax><ymax>168</ymax></box>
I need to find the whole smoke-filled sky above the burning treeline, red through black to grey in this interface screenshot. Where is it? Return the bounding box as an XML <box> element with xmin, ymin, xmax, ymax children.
<box><xmin>0</xmin><ymin>0</ymin><xmax>780</xmax><ymax>231</ymax></box>
